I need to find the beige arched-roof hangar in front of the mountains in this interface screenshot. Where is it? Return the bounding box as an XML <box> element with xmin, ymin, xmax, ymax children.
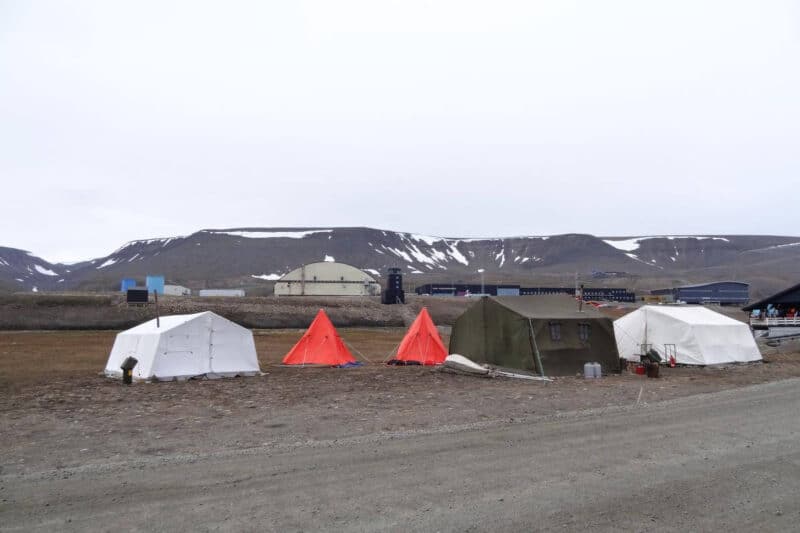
<box><xmin>275</xmin><ymin>261</ymin><xmax>381</xmax><ymax>296</ymax></box>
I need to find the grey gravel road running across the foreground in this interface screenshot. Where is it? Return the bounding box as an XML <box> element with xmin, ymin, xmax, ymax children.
<box><xmin>0</xmin><ymin>379</ymin><xmax>800</xmax><ymax>531</ymax></box>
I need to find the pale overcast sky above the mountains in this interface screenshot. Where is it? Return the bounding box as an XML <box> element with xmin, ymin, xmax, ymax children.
<box><xmin>0</xmin><ymin>0</ymin><xmax>800</xmax><ymax>261</ymax></box>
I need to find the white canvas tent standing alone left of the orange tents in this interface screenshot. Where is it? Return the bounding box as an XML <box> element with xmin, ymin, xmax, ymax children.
<box><xmin>105</xmin><ymin>311</ymin><xmax>259</xmax><ymax>381</ymax></box>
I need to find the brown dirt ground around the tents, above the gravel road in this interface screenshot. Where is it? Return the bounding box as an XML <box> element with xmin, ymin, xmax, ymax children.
<box><xmin>0</xmin><ymin>328</ymin><xmax>800</xmax><ymax>478</ymax></box>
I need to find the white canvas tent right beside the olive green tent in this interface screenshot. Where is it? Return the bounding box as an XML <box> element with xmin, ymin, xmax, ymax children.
<box><xmin>614</xmin><ymin>305</ymin><xmax>761</xmax><ymax>365</ymax></box>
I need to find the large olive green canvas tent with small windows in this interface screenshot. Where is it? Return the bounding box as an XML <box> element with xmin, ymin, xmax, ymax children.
<box><xmin>450</xmin><ymin>295</ymin><xmax>619</xmax><ymax>376</ymax></box>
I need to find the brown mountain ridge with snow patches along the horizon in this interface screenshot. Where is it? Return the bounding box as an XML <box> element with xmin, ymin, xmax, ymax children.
<box><xmin>0</xmin><ymin>227</ymin><xmax>800</xmax><ymax>290</ymax></box>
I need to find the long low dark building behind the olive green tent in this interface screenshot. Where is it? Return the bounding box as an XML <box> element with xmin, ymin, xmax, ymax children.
<box><xmin>416</xmin><ymin>283</ymin><xmax>636</xmax><ymax>302</ymax></box>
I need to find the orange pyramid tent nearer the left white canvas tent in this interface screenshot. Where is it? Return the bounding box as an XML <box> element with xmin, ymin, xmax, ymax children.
<box><xmin>283</xmin><ymin>309</ymin><xmax>356</xmax><ymax>366</ymax></box>
